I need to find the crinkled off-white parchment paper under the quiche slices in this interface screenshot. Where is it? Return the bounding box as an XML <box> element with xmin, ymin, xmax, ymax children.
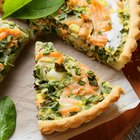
<box><xmin>0</xmin><ymin>31</ymin><xmax>139</xmax><ymax>140</ymax></box>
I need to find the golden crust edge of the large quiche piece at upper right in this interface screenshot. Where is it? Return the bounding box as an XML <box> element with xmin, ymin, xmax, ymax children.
<box><xmin>111</xmin><ymin>0</ymin><xmax>140</xmax><ymax>70</ymax></box>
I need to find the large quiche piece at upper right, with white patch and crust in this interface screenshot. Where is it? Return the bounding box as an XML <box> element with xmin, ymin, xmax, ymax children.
<box><xmin>31</xmin><ymin>0</ymin><xmax>140</xmax><ymax>70</ymax></box>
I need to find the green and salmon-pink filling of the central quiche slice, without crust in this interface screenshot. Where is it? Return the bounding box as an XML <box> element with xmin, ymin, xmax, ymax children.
<box><xmin>34</xmin><ymin>42</ymin><xmax>122</xmax><ymax>131</ymax></box>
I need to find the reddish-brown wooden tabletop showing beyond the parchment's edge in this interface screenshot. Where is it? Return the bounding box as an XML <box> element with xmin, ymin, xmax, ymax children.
<box><xmin>70</xmin><ymin>41</ymin><xmax>140</xmax><ymax>140</ymax></box>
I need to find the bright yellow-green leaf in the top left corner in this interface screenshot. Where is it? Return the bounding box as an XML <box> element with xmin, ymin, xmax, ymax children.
<box><xmin>2</xmin><ymin>0</ymin><xmax>32</xmax><ymax>19</ymax></box>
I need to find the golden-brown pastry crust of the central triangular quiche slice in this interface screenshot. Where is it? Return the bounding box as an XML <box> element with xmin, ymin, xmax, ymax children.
<box><xmin>38</xmin><ymin>86</ymin><xmax>123</xmax><ymax>134</ymax></box>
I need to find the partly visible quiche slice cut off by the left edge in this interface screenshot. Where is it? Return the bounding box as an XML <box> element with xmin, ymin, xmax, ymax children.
<box><xmin>0</xmin><ymin>19</ymin><xmax>29</xmax><ymax>82</ymax></box>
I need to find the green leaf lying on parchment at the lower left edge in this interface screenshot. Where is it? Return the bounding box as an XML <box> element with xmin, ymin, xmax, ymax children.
<box><xmin>0</xmin><ymin>96</ymin><xmax>16</xmax><ymax>140</ymax></box>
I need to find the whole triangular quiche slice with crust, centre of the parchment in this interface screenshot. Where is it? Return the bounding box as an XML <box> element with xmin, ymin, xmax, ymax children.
<box><xmin>34</xmin><ymin>42</ymin><xmax>123</xmax><ymax>134</ymax></box>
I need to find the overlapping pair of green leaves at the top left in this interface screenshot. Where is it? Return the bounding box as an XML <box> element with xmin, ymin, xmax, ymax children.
<box><xmin>2</xmin><ymin>0</ymin><xmax>65</xmax><ymax>19</ymax></box>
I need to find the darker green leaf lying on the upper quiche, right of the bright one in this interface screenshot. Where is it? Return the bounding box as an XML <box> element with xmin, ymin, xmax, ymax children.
<box><xmin>12</xmin><ymin>0</ymin><xmax>65</xmax><ymax>19</ymax></box>
